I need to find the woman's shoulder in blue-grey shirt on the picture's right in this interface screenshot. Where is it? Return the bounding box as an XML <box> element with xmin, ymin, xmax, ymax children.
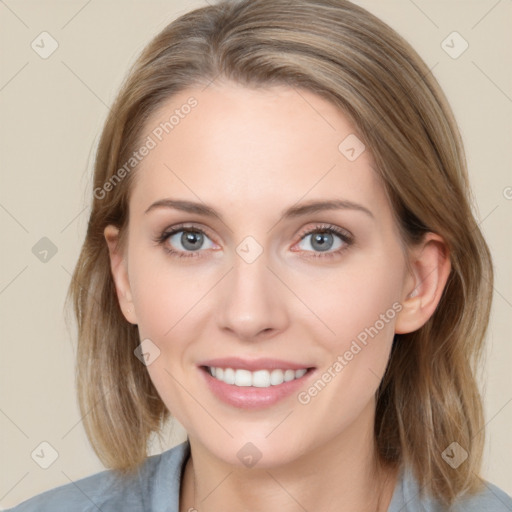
<box><xmin>388</xmin><ymin>468</ymin><xmax>512</xmax><ymax>512</ymax></box>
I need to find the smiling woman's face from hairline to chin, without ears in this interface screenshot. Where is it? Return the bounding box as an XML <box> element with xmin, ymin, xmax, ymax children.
<box><xmin>109</xmin><ymin>82</ymin><xmax>416</xmax><ymax>467</ymax></box>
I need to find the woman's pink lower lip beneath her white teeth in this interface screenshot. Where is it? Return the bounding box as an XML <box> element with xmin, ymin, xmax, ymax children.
<box><xmin>199</xmin><ymin>367</ymin><xmax>315</xmax><ymax>409</ymax></box>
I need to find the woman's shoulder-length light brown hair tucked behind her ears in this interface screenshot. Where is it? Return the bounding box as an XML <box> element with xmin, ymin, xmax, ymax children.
<box><xmin>66</xmin><ymin>0</ymin><xmax>493</xmax><ymax>504</ymax></box>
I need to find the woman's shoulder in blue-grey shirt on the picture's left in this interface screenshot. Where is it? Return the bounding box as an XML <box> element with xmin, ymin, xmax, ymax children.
<box><xmin>7</xmin><ymin>441</ymin><xmax>190</xmax><ymax>512</ymax></box>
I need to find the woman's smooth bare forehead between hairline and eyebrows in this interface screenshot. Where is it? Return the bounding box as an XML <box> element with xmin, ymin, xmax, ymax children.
<box><xmin>131</xmin><ymin>83</ymin><xmax>386</xmax><ymax>220</ymax></box>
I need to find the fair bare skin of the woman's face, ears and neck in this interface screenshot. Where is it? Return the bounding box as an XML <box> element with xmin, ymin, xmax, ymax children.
<box><xmin>105</xmin><ymin>82</ymin><xmax>450</xmax><ymax>512</ymax></box>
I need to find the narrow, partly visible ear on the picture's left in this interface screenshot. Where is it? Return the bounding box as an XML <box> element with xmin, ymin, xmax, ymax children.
<box><xmin>103</xmin><ymin>225</ymin><xmax>137</xmax><ymax>324</ymax></box>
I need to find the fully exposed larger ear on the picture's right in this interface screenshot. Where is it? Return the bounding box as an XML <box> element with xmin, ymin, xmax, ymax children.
<box><xmin>395</xmin><ymin>232</ymin><xmax>451</xmax><ymax>334</ymax></box>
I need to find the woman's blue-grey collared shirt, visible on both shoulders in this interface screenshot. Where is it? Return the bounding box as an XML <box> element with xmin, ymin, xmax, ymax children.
<box><xmin>7</xmin><ymin>440</ymin><xmax>512</xmax><ymax>512</ymax></box>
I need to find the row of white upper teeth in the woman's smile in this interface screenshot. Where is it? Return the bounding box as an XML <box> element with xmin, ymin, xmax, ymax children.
<box><xmin>208</xmin><ymin>366</ymin><xmax>307</xmax><ymax>388</ymax></box>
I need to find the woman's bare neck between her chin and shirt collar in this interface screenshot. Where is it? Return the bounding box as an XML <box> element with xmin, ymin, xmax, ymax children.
<box><xmin>180</xmin><ymin>402</ymin><xmax>398</xmax><ymax>512</ymax></box>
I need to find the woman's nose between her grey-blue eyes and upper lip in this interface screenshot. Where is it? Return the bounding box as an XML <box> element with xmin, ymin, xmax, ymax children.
<box><xmin>217</xmin><ymin>253</ymin><xmax>289</xmax><ymax>341</ymax></box>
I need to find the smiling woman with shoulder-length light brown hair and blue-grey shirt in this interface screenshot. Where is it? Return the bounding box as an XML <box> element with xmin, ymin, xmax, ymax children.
<box><xmin>6</xmin><ymin>0</ymin><xmax>512</xmax><ymax>512</ymax></box>
